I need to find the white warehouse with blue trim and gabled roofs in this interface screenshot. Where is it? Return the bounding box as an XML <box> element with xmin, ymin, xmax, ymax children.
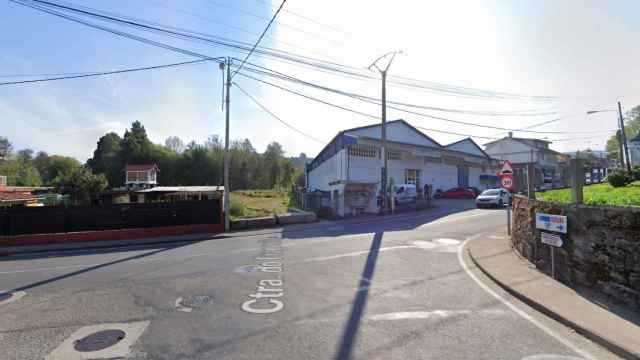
<box><xmin>307</xmin><ymin>120</ymin><xmax>500</xmax><ymax>216</ymax></box>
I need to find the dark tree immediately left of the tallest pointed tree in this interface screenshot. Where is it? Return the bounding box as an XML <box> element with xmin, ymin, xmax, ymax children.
<box><xmin>87</xmin><ymin>132</ymin><xmax>124</xmax><ymax>186</ymax></box>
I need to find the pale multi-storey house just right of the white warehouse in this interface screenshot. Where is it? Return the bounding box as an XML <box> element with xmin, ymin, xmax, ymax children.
<box><xmin>484</xmin><ymin>133</ymin><xmax>569</xmax><ymax>190</ymax></box>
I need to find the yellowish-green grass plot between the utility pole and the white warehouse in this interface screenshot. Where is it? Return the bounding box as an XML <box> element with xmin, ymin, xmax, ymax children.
<box><xmin>229</xmin><ymin>190</ymin><xmax>289</xmax><ymax>219</ymax></box>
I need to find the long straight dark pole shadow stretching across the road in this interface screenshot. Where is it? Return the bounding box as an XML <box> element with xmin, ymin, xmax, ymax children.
<box><xmin>336</xmin><ymin>232</ymin><xmax>383</xmax><ymax>360</ymax></box>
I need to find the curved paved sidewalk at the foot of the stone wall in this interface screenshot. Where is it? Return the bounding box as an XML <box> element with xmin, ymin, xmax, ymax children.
<box><xmin>467</xmin><ymin>235</ymin><xmax>640</xmax><ymax>359</ymax></box>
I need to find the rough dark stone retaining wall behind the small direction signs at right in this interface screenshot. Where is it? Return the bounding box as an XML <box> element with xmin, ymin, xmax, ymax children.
<box><xmin>511</xmin><ymin>196</ymin><xmax>640</xmax><ymax>310</ymax></box>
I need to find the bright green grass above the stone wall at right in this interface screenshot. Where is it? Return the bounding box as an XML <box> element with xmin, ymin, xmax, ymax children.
<box><xmin>536</xmin><ymin>181</ymin><xmax>640</xmax><ymax>206</ymax></box>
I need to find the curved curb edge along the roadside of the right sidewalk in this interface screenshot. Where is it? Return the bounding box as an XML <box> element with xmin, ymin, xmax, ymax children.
<box><xmin>467</xmin><ymin>249</ymin><xmax>640</xmax><ymax>360</ymax></box>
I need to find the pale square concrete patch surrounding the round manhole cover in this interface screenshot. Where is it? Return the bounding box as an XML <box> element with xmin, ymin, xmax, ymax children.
<box><xmin>45</xmin><ymin>321</ymin><xmax>149</xmax><ymax>360</ymax></box>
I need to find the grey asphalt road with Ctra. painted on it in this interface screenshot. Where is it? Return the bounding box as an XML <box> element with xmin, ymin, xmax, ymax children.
<box><xmin>0</xmin><ymin>201</ymin><xmax>614</xmax><ymax>360</ymax></box>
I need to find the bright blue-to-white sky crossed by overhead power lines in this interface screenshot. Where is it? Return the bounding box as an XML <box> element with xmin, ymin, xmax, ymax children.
<box><xmin>0</xmin><ymin>0</ymin><xmax>640</xmax><ymax>161</ymax></box>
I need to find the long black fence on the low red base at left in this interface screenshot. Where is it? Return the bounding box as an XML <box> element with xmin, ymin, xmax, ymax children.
<box><xmin>0</xmin><ymin>200</ymin><xmax>221</xmax><ymax>236</ymax></box>
